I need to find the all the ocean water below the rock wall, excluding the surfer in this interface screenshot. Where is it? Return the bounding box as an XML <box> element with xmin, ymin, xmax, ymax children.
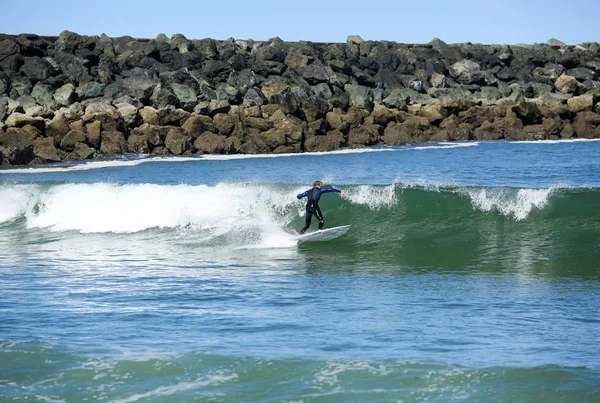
<box><xmin>0</xmin><ymin>141</ymin><xmax>600</xmax><ymax>402</ymax></box>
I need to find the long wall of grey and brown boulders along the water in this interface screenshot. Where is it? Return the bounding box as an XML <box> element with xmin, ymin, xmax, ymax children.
<box><xmin>0</xmin><ymin>31</ymin><xmax>600</xmax><ymax>166</ymax></box>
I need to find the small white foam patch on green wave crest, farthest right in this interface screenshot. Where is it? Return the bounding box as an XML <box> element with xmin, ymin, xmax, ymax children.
<box><xmin>466</xmin><ymin>188</ymin><xmax>552</xmax><ymax>221</ymax></box>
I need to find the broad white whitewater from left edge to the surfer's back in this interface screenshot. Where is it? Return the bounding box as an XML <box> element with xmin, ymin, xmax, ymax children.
<box><xmin>0</xmin><ymin>183</ymin><xmax>305</xmax><ymax>249</ymax></box>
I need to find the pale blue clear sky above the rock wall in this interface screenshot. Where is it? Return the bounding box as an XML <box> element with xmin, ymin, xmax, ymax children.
<box><xmin>0</xmin><ymin>0</ymin><xmax>600</xmax><ymax>45</ymax></box>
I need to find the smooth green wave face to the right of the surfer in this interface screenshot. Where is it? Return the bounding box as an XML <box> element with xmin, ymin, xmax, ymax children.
<box><xmin>295</xmin><ymin>185</ymin><xmax>600</xmax><ymax>275</ymax></box>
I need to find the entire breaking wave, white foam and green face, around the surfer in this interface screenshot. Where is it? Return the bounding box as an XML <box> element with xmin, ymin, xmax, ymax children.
<box><xmin>0</xmin><ymin>183</ymin><xmax>600</xmax><ymax>275</ymax></box>
